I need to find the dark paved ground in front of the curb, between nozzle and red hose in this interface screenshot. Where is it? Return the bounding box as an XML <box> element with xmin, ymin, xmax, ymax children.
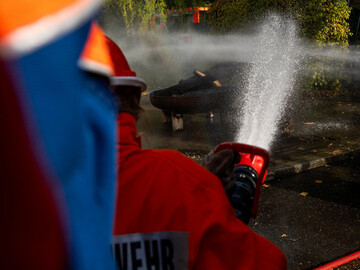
<box><xmin>250</xmin><ymin>157</ymin><xmax>360</xmax><ymax>270</ymax></box>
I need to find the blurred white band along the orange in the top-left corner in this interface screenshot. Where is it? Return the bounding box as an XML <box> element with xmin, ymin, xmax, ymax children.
<box><xmin>0</xmin><ymin>0</ymin><xmax>102</xmax><ymax>58</ymax></box>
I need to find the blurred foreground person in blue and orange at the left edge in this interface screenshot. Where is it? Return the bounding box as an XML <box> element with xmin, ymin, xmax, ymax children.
<box><xmin>0</xmin><ymin>0</ymin><xmax>116</xmax><ymax>270</ymax></box>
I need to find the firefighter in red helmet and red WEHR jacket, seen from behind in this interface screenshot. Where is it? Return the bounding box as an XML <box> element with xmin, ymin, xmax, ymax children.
<box><xmin>108</xmin><ymin>36</ymin><xmax>286</xmax><ymax>270</ymax></box>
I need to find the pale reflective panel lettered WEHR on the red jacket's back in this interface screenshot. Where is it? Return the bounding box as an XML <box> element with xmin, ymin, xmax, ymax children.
<box><xmin>112</xmin><ymin>232</ymin><xmax>189</xmax><ymax>270</ymax></box>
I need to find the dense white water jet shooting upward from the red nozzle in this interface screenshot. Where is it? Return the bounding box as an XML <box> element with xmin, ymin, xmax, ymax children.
<box><xmin>235</xmin><ymin>15</ymin><xmax>300</xmax><ymax>150</ymax></box>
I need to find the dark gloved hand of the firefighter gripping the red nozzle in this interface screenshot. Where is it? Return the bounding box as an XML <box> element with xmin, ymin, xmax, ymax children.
<box><xmin>202</xmin><ymin>149</ymin><xmax>238</xmax><ymax>194</ymax></box>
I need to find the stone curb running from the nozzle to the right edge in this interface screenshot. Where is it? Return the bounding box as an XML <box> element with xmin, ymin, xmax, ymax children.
<box><xmin>265</xmin><ymin>148</ymin><xmax>360</xmax><ymax>181</ymax></box>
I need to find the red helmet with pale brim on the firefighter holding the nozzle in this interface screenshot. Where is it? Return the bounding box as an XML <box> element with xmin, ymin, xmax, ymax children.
<box><xmin>106</xmin><ymin>37</ymin><xmax>146</xmax><ymax>91</ymax></box>
